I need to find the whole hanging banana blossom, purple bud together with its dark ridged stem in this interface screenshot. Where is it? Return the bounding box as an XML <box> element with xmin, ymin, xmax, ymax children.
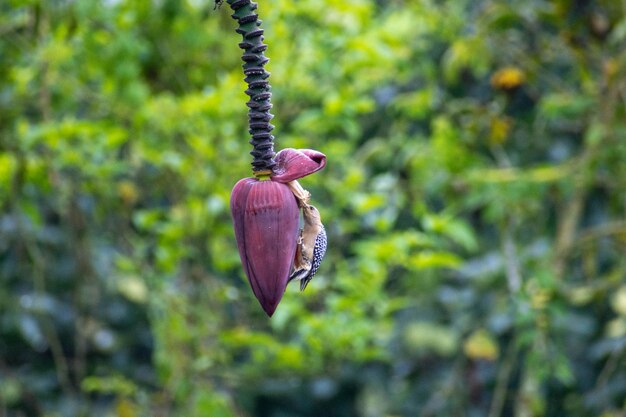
<box><xmin>223</xmin><ymin>0</ymin><xmax>326</xmax><ymax>316</ymax></box>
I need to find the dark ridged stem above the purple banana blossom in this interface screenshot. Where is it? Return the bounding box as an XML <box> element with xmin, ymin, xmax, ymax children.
<box><xmin>226</xmin><ymin>0</ymin><xmax>275</xmax><ymax>175</ymax></box>
